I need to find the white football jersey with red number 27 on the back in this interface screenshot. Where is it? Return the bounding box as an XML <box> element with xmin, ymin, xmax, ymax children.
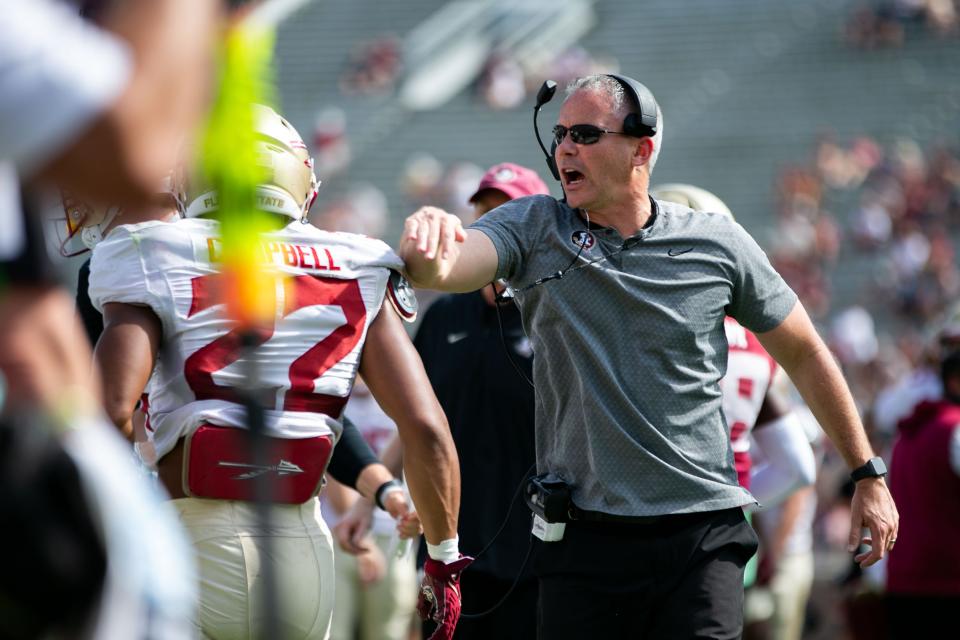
<box><xmin>90</xmin><ymin>218</ymin><xmax>403</xmax><ymax>457</ymax></box>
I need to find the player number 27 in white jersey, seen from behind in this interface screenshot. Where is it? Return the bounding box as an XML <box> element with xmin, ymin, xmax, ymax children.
<box><xmin>90</xmin><ymin>105</ymin><xmax>469</xmax><ymax>639</ymax></box>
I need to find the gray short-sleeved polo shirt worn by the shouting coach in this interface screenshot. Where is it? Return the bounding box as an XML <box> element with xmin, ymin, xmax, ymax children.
<box><xmin>472</xmin><ymin>196</ymin><xmax>797</xmax><ymax>516</ymax></box>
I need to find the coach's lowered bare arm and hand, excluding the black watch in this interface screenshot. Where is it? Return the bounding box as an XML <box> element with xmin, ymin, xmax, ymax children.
<box><xmin>757</xmin><ymin>302</ymin><xmax>899</xmax><ymax>566</ymax></box>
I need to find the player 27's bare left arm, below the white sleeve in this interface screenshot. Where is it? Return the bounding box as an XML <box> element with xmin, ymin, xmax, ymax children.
<box><xmin>94</xmin><ymin>302</ymin><xmax>163</xmax><ymax>441</ymax></box>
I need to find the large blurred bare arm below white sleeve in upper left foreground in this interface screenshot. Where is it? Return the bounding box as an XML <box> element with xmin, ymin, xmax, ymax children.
<box><xmin>33</xmin><ymin>0</ymin><xmax>223</xmax><ymax>209</ymax></box>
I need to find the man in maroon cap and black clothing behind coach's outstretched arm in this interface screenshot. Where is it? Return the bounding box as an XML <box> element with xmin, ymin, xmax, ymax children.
<box><xmin>414</xmin><ymin>162</ymin><xmax>549</xmax><ymax>640</ymax></box>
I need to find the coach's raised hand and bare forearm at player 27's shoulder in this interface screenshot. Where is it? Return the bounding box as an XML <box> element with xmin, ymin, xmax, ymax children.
<box><xmin>398</xmin><ymin>207</ymin><xmax>497</xmax><ymax>293</ymax></box>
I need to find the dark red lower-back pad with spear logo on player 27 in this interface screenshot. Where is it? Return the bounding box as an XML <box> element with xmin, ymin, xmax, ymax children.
<box><xmin>183</xmin><ymin>424</ymin><xmax>333</xmax><ymax>504</ymax></box>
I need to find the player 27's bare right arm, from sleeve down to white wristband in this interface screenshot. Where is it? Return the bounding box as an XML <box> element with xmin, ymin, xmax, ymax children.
<box><xmin>360</xmin><ymin>304</ymin><xmax>460</xmax><ymax>545</ymax></box>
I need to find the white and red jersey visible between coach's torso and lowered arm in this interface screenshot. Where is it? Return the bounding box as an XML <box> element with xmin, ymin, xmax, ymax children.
<box><xmin>720</xmin><ymin>317</ymin><xmax>777</xmax><ymax>488</ymax></box>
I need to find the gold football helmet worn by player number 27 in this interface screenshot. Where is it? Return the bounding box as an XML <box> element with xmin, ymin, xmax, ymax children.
<box><xmin>183</xmin><ymin>104</ymin><xmax>320</xmax><ymax>220</ymax></box>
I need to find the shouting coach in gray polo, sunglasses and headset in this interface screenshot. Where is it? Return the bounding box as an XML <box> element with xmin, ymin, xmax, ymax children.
<box><xmin>400</xmin><ymin>76</ymin><xmax>897</xmax><ymax>639</ymax></box>
